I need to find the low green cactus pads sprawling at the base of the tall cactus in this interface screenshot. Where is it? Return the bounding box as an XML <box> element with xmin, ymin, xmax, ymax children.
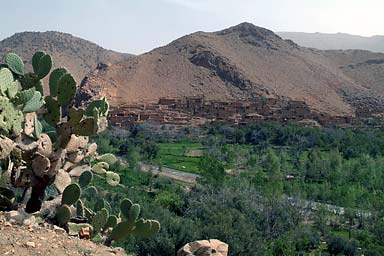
<box><xmin>56</xmin><ymin>171</ymin><xmax>160</xmax><ymax>245</ymax></box>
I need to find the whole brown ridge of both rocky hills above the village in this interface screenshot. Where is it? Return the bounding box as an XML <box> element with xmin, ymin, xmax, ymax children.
<box><xmin>0</xmin><ymin>22</ymin><xmax>384</xmax><ymax>121</ymax></box>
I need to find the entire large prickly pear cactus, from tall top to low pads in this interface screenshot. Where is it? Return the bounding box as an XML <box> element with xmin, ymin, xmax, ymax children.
<box><xmin>0</xmin><ymin>52</ymin><xmax>159</xmax><ymax>241</ymax></box>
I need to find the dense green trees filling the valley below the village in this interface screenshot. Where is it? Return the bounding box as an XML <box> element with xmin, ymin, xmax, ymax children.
<box><xmin>94</xmin><ymin>123</ymin><xmax>384</xmax><ymax>255</ymax></box>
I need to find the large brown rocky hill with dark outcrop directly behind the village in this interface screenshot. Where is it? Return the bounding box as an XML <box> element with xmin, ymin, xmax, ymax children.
<box><xmin>80</xmin><ymin>23</ymin><xmax>384</xmax><ymax>116</ymax></box>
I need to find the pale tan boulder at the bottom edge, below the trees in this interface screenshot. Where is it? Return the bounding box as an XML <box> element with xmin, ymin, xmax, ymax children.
<box><xmin>177</xmin><ymin>239</ymin><xmax>228</xmax><ymax>256</ymax></box>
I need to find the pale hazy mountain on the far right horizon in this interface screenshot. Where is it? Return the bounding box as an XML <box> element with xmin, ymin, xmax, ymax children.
<box><xmin>277</xmin><ymin>32</ymin><xmax>384</xmax><ymax>52</ymax></box>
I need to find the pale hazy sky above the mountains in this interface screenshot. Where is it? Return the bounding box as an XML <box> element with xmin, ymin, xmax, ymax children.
<box><xmin>0</xmin><ymin>0</ymin><xmax>384</xmax><ymax>53</ymax></box>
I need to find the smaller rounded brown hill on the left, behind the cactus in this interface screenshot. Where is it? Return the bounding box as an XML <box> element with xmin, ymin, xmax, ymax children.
<box><xmin>0</xmin><ymin>31</ymin><xmax>131</xmax><ymax>86</ymax></box>
